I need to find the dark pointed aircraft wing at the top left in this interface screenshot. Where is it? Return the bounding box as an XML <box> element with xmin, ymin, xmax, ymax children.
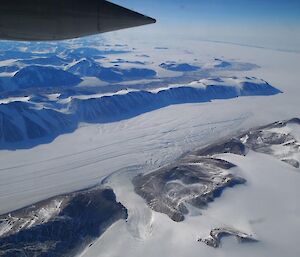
<box><xmin>0</xmin><ymin>0</ymin><xmax>156</xmax><ymax>41</ymax></box>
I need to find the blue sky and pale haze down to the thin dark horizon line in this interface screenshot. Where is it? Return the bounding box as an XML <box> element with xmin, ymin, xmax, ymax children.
<box><xmin>112</xmin><ymin>0</ymin><xmax>300</xmax><ymax>51</ymax></box>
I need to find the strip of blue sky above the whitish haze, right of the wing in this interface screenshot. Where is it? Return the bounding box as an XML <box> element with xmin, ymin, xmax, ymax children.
<box><xmin>113</xmin><ymin>0</ymin><xmax>300</xmax><ymax>24</ymax></box>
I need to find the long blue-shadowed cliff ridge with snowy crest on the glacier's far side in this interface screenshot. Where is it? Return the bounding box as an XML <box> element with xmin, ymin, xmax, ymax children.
<box><xmin>0</xmin><ymin>76</ymin><xmax>280</xmax><ymax>149</ymax></box>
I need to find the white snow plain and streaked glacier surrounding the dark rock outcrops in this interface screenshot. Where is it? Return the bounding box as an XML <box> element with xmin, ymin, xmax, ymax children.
<box><xmin>0</xmin><ymin>38</ymin><xmax>300</xmax><ymax>257</ymax></box>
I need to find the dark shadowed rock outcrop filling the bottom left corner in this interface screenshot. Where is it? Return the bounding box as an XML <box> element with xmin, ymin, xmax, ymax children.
<box><xmin>0</xmin><ymin>187</ymin><xmax>127</xmax><ymax>257</ymax></box>
